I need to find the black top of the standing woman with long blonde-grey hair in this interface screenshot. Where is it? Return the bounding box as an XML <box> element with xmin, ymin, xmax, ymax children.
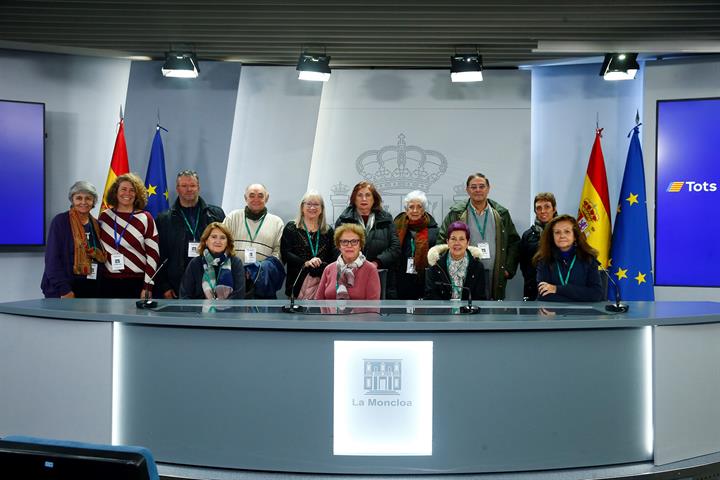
<box><xmin>280</xmin><ymin>222</ymin><xmax>338</xmax><ymax>297</ymax></box>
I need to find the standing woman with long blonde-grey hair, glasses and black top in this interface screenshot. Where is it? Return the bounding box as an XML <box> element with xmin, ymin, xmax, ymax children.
<box><xmin>280</xmin><ymin>190</ymin><xmax>337</xmax><ymax>298</ymax></box>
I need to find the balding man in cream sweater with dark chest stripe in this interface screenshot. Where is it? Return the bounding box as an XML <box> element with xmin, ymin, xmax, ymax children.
<box><xmin>224</xmin><ymin>183</ymin><xmax>285</xmax><ymax>298</ymax></box>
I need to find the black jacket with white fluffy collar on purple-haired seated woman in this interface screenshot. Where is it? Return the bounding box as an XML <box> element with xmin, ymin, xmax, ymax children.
<box><xmin>425</xmin><ymin>245</ymin><xmax>486</xmax><ymax>300</ymax></box>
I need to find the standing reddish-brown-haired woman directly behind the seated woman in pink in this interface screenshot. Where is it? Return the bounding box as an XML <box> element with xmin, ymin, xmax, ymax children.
<box><xmin>335</xmin><ymin>182</ymin><xmax>400</xmax><ymax>268</ymax></box>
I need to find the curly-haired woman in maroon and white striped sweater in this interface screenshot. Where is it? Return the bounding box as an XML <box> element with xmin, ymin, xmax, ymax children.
<box><xmin>100</xmin><ymin>173</ymin><xmax>160</xmax><ymax>298</ymax></box>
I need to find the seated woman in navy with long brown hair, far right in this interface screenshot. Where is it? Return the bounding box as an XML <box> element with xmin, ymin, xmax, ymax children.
<box><xmin>533</xmin><ymin>215</ymin><xmax>603</xmax><ymax>302</ymax></box>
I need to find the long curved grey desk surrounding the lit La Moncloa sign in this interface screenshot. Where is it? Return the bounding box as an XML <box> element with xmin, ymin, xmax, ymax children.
<box><xmin>0</xmin><ymin>300</ymin><xmax>720</xmax><ymax>474</ymax></box>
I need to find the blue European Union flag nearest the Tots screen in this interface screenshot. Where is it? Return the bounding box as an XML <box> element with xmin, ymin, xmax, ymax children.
<box><xmin>608</xmin><ymin>125</ymin><xmax>655</xmax><ymax>301</ymax></box>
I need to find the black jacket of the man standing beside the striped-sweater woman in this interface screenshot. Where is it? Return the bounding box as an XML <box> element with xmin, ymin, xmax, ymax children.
<box><xmin>155</xmin><ymin>197</ymin><xmax>225</xmax><ymax>298</ymax></box>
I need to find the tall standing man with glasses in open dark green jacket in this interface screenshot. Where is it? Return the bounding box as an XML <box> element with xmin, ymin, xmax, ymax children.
<box><xmin>437</xmin><ymin>173</ymin><xmax>520</xmax><ymax>300</ymax></box>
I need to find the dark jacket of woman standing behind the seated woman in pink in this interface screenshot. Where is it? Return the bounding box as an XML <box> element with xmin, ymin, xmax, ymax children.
<box><xmin>335</xmin><ymin>205</ymin><xmax>400</xmax><ymax>269</ymax></box>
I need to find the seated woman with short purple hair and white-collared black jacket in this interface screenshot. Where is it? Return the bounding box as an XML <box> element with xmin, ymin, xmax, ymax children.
<box><xmin>425</xmin><ymin>222</ymin><xmax>485</xmax><ymax>300</ymax></box>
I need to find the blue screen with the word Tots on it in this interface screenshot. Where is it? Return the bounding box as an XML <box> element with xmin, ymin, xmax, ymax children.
<box><xmin>655</xmin><ymin>98</ymin><xmax>720</xmax><ymax>287</ymax></box>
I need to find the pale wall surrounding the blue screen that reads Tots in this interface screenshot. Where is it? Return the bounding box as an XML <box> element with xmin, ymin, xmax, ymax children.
<box><xmin>641</xmin><ymin>56</ymin><xmax>720</xmax><ymax>302</ymax></box>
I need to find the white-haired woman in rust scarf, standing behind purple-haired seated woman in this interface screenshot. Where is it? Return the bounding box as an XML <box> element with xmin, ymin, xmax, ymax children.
<box><xmin>394</xmin><ymin>190</ymin><xmax>438</xmax><ymax>300</ymax></box>
